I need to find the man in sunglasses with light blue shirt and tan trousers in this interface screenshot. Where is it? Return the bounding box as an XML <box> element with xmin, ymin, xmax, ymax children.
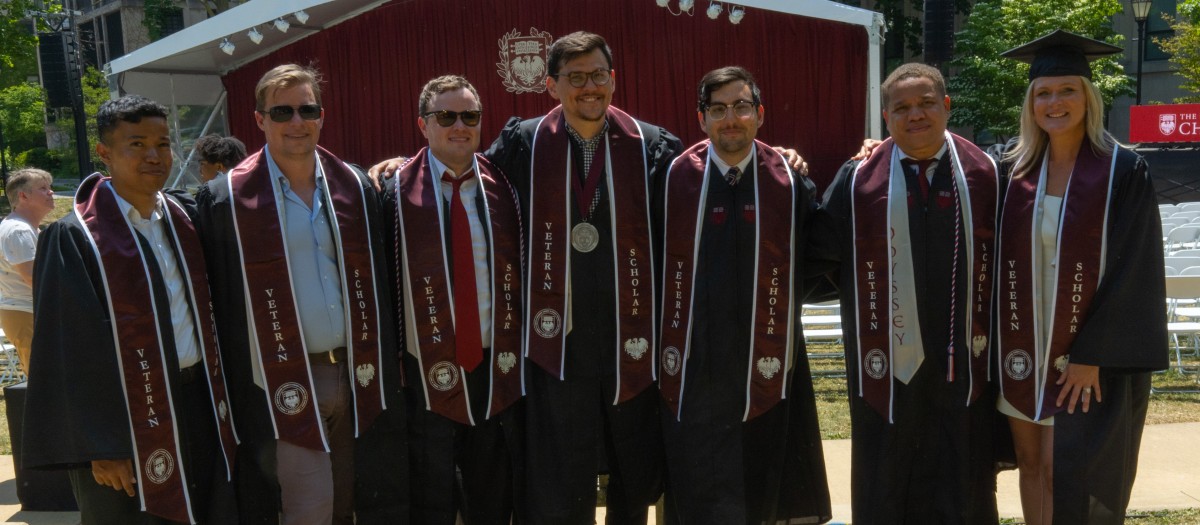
<box><xmin>197</xmin><ymin>65</ymin><xmax>408</xmax><ymax>525</ymax></box>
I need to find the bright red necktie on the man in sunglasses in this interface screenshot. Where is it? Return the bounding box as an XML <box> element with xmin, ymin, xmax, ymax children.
<box><xmin>442</xmin><ymin>170</ymin><xmax>484</xmax><ymax>372</ymax></box>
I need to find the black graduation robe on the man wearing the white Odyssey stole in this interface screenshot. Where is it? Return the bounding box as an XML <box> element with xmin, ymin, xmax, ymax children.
<box><xmin>808</xmin><ymin>152</ymin><xmax>998</xmax><ymax>524</ymax></box>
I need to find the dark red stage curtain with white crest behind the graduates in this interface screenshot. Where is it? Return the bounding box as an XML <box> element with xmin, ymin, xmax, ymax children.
<box><xmin>223</xmin><ymin>0</ymin><xmax>868</xmax><ymax>187</ymax></box>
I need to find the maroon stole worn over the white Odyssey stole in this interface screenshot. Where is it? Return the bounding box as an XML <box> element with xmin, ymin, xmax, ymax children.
<box><xmin>847</xmin><ymin>132</ymin><xmax>1000</xmax><ymax>422</ymax></box>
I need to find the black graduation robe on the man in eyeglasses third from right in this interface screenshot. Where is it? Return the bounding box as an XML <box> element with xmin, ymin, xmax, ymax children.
<box><xmin>654</xmin><ymin>163</ymin><xmax>833</xmax><ymax>525</ymax></box>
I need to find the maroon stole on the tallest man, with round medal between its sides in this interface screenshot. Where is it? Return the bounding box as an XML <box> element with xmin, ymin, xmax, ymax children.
<box><xmin>524</xmin><ymin>105</ymin><xmax>655</xmax><ymax>404</ymax></box>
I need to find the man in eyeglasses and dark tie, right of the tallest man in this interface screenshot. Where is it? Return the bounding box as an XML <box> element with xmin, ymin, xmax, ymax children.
<box><xmin>655</xmin><ymin>67</ymin><xmax>832</xmax><ymax>524</ymax></box>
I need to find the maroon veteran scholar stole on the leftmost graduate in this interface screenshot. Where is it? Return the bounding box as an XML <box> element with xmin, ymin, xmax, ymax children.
<box><xmin>74</xmin><ymin>174</ymin><xmax>238</xmax><ymax>523</ymax></box>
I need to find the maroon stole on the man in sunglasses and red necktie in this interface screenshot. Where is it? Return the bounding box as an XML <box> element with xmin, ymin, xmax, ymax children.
<box><xmin>396</xmin><ymin>147</ymin><xmax>524</xmax><ymax>424</ymax></box>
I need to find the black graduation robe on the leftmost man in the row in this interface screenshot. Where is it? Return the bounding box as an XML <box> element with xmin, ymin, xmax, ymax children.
<box><xmin>22</xmin><ymin>191</ymin><xmax>235</xmax><ymax>523</ymax></box>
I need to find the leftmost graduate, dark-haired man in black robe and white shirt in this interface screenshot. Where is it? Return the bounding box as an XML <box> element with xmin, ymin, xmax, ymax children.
<box><xmin>22</xmin><ymin>96</ymin><xmax>236</xmax><ymax>525</ymax></box>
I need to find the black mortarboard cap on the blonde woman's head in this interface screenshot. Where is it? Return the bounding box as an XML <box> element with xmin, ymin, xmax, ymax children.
<box><xmin>1000</xmin><ymin>29</ymin><xmax>1123</xmax><ymax>80</ymax></box>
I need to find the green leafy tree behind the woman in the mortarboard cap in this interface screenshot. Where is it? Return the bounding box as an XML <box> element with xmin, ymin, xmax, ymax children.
<box><xmin>947</xmin><ymin>0</ymin><xmax>1132</xmax><ymax>140</ymax></box>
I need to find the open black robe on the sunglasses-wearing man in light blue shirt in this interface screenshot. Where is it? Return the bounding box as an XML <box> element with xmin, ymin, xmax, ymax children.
<box><xmin>196</xmin><ymin>161</ymin><xmax>408</xmax><ymax>525</ymax></box>
